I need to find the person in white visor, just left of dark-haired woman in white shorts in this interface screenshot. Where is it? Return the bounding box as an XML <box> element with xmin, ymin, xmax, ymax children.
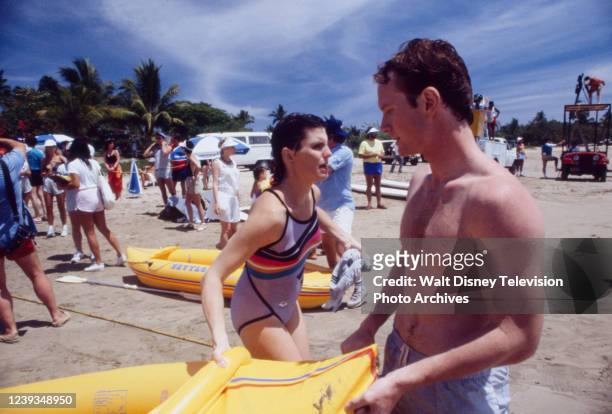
<box><xmin>41</xmin><ymin>139</ymin><xmax>68</xmax><ymax>237</ymax></box>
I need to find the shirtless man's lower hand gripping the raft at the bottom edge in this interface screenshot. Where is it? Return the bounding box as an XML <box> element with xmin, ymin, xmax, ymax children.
<box><xmin>346</xmin><ymin>376</ymin><xmax>402</xmax><ymax>414</ymax></box>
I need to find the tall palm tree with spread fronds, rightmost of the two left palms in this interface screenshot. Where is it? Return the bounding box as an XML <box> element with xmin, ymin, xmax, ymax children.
<box><xmin>121</xmin><ymin>59</ymin><xmax>183</xmax><ymax>139</ymax></box>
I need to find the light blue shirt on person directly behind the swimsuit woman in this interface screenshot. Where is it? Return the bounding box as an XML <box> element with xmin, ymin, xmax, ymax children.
<box><xmin>317</xmin><ymin>144</ymin><xmax>355</xmax><ymax>211</ymax></box>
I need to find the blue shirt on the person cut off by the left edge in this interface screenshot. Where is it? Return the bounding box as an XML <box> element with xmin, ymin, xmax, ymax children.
<box><xmin>0</xmin><ymin>150</ymin><xmax>25</xmax><ymax>249</ymax></box>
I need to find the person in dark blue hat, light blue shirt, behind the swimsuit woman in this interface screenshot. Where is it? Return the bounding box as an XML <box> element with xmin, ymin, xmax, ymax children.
<box><xmin>317</xmin><ymin>116</ymin><xmax>355</xmax><ymax>269</ymax></box>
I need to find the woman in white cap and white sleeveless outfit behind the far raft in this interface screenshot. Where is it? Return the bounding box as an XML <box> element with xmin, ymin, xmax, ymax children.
<box><xmin>213</xmin><ymin>138</ymin><xmax>240</xmax><ymax>250</ymax></box>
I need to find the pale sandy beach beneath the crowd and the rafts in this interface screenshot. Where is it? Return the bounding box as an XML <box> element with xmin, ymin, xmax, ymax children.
<box><xmin>0</xmin><ymin>149</ymin><xmax>612</xmax><ymax>413</ymax></box>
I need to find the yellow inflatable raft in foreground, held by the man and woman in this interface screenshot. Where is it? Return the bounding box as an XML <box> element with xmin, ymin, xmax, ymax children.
<box><xmin>0</xmin><ymin>345</ymin><xmax>376</xmax><ymax>414</ymax></box>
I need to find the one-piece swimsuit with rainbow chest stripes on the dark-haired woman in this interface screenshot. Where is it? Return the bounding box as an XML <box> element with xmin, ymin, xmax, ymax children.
<box><xmin>231</xmin><ymin>190</ymin><xmax>321</xmax><ymax>333</ymax></box>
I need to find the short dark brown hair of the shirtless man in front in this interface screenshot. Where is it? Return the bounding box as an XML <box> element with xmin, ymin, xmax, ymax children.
<box><xmin>374</xmin><ymin>39</ymin><xmax>473</xmax><ymax>123</ymax></box>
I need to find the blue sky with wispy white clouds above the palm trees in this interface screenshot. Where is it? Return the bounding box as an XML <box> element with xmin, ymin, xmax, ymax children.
<box><xmin>0</xmin><ymin>0</ymin><xmax>612</xmax><ymax>130</ymax></box>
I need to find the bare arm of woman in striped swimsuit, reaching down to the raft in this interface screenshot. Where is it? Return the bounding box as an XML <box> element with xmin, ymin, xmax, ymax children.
<box><xmin>201</xmin><ymin>195</ymin><xmax>285</xmax><ymax>365</ymax></box>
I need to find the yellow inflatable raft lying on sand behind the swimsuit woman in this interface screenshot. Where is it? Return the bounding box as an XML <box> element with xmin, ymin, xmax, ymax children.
<box><xmin>127</xmin><ymin>246</ymin><xmax>331</xmax><ymax>309</ymax></box>
